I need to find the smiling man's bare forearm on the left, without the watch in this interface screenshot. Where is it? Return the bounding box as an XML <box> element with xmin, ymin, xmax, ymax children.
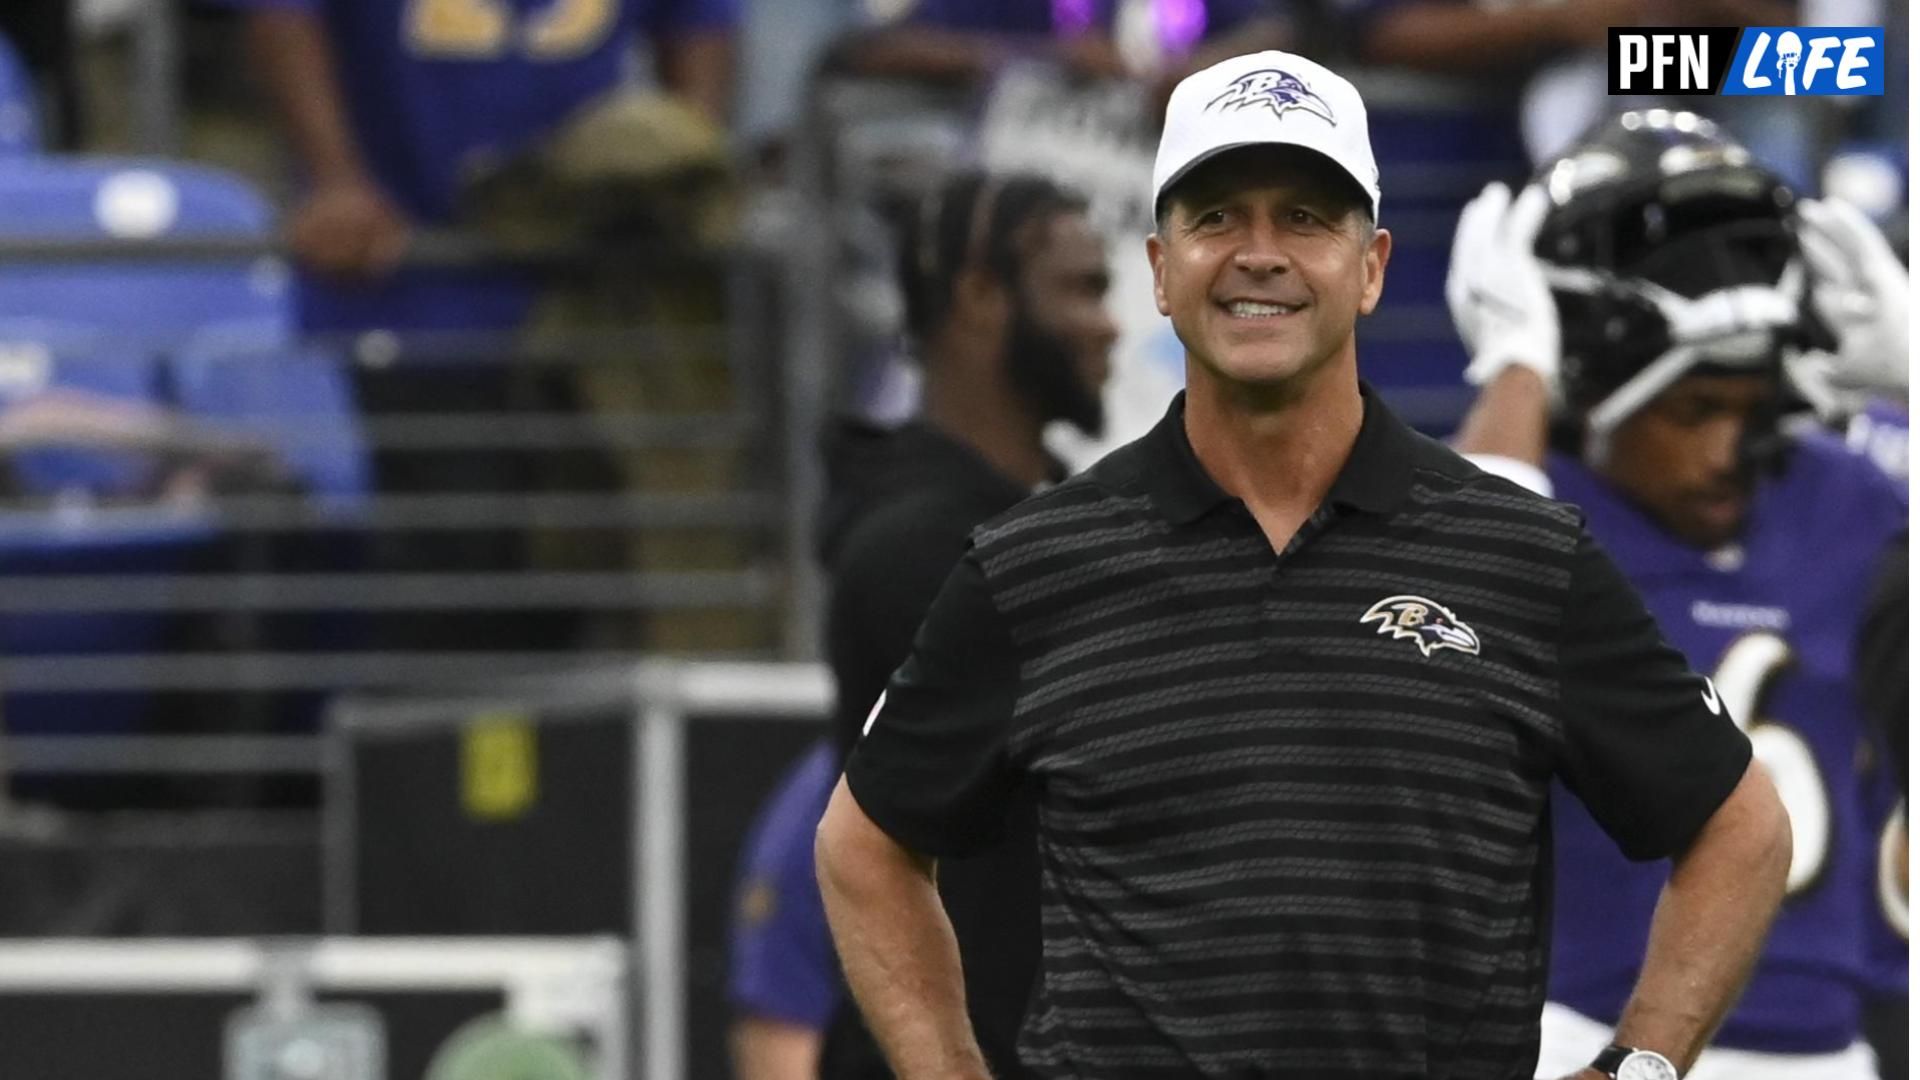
<box><xmin>814</xmin><ymin>780</ymin><xmax>989</xmax><ymax>1080</ymax></box>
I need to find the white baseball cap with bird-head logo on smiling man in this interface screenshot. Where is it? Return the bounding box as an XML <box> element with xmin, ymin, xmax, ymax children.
<box><xmin>1154</xmin><ymin>50</ymin><xmax>1380</xmax><ymax>221</ymax></box>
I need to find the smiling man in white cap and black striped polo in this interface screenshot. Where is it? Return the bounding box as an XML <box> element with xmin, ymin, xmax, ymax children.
<box><xmin>818</xmin><ymin>52</ymin><xmax>1791</xmax><ymax>1080</ymax></box>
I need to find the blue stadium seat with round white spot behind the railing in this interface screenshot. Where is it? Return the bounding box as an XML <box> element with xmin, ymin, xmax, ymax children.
<box><xmin>0</xmin><ymin>158</ymin><xmax>367</xmax><ymax>500</ymax></box>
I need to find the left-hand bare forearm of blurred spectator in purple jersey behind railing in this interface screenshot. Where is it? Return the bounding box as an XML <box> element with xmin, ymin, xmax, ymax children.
<box><xmin>246</xmin><ymin>8</ymin><xmax>367</xmax><ymax>184</ymax></box>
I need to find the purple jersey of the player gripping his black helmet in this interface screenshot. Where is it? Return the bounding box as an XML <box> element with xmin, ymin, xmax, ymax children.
<box><xmin>1548</xmin><ymin>434</ymin><xmax>1907</xmax><ymax>1053</ymax></box>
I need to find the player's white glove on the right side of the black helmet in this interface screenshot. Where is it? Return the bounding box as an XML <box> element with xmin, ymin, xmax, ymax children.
<box><xmin>1799</xmin><ymin>198</ymin><xmax>1907</xmax><ymax>398</ymax></box>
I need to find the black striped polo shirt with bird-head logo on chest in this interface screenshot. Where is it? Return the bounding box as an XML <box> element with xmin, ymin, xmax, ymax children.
<box><xmin>847</xmin><ymin>388</ymin><xmax>1749</xmax><ymax>1080</ymax></box>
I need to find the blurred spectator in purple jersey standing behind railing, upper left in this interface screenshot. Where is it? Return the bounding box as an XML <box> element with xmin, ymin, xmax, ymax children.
<box><xmin>225</xmin><ymin>0</ymin><xmax>737</xmax><ymax>650</ymax></box>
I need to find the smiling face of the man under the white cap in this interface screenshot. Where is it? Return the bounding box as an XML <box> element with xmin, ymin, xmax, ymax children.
<box><xmin>1146</xmin><ymin>146</ymin><xmax>1392</xmax><ymax>390</ymax></box>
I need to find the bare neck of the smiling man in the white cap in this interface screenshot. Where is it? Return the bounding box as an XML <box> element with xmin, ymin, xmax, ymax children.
<box><xmin>1185</xmin><ymin>363</ymin><xmax>1365</xmax><ymax>526</ymax></box>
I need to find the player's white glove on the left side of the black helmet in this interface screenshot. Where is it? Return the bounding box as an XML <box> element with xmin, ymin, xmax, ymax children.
<box><xmin>1446</xmin><ymin>183</ymin><xmax>1561</xmax><ymax>398</ymax></box>
